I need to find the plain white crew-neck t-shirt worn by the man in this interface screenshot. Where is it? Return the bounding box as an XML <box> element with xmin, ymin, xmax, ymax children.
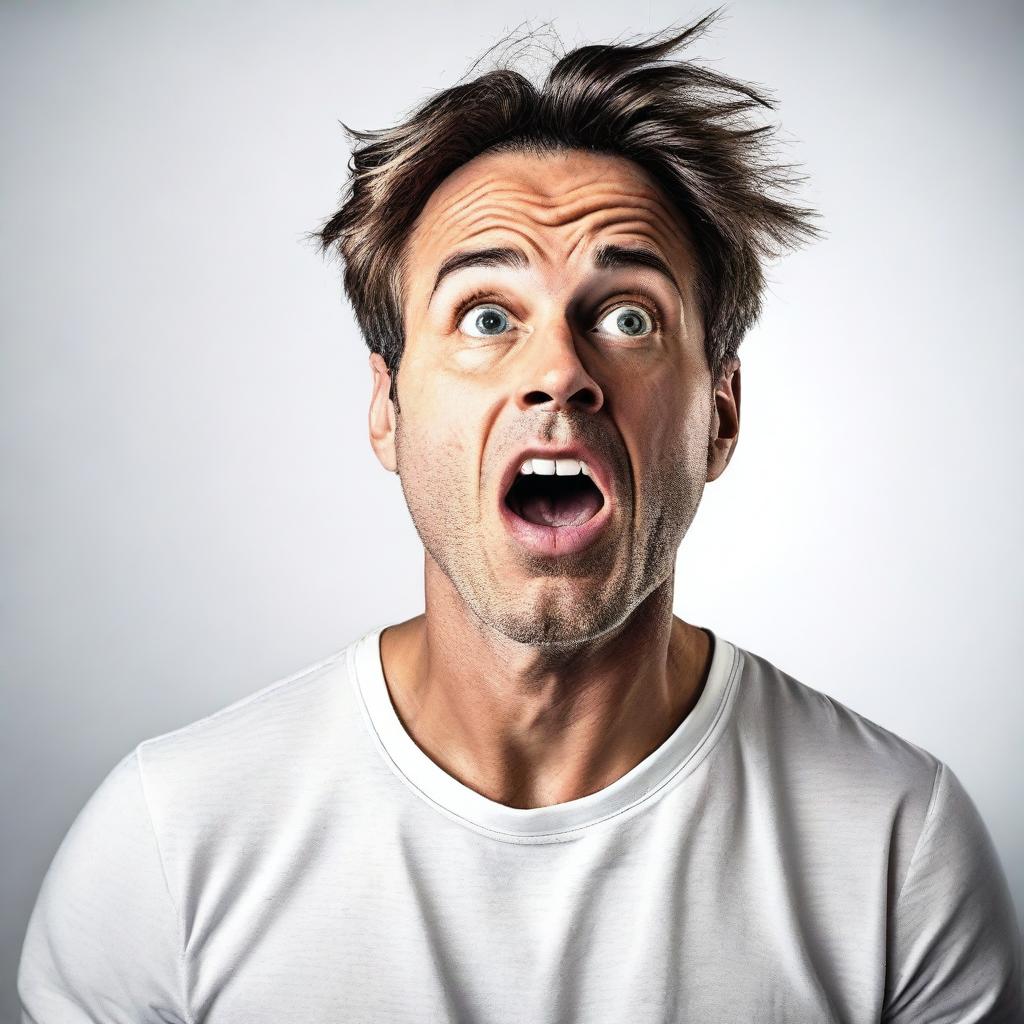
<box><xmin>18</xmin><ymin>630</ymin><xmax>1022</xmax><ymax>1024</ymax></box>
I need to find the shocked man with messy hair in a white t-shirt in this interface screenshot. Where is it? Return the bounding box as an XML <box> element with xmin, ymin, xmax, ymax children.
<box><xmin>19</xmin><ymin>9</ymin><xmax>1021</xmax><ymax>1024</ymax></box>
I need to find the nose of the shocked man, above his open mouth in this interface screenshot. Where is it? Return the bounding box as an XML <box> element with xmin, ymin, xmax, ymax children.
<box><xmin>517</xmin><ymin>319</ymin><xmax>604</xmax><ymax>413</ymax></box>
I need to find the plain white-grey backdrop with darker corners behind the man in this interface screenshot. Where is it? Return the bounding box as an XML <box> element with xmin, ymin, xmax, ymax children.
<box><xmin>0</xmin><ymin>0</ymin><xmax>1024</xmax><ymax>1007</ymax></box>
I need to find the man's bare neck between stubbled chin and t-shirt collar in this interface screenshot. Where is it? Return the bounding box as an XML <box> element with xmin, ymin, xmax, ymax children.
<box><xmin>381</xmin><ymin>555</ymin><xmax>711</xmax><ymax>808</ymax></box>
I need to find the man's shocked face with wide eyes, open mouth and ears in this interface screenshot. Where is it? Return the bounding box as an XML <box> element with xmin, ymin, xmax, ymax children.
<box><xmin>370</xmin><ymin>151</ymin><xmax>738</xmax><ymax>644</ymax></box>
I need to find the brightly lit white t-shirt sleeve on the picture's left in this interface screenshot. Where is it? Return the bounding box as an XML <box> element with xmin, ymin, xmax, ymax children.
<box><xmin>17</xmin><ymin>750</ymin><xmax>188</xmax><ymax>1024</ymax></box>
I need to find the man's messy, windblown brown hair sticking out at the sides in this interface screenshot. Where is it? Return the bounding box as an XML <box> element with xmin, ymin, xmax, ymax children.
<box><xmin>310</xmin><ymin>7</ymin><xmax>822</xmax><ymax>407</ymax></box>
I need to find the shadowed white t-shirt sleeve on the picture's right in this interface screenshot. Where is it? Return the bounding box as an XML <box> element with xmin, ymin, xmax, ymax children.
<box><xmin>882</xmin><ymin>762</ymin><xmax>1024</xmax><ymax>1024</ymax></box>
